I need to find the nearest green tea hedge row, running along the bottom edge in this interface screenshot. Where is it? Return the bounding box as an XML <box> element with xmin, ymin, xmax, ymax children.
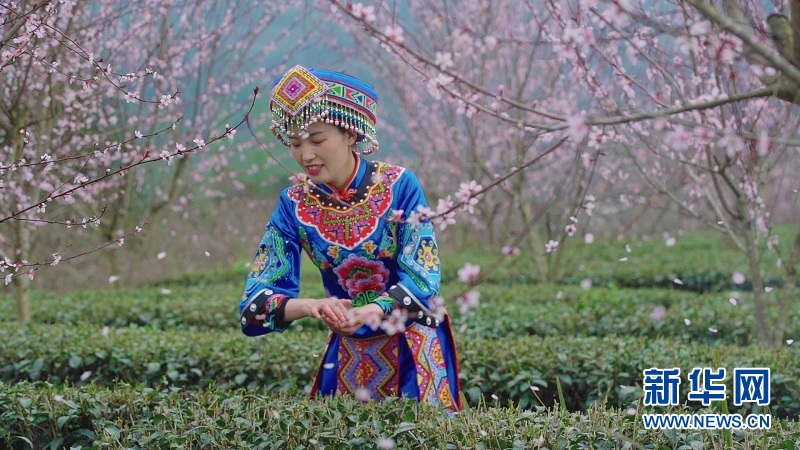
<box><xmin>0</xmin><ymin>383</ymin><xmax>800</xmax><ymax>450</ymax></box>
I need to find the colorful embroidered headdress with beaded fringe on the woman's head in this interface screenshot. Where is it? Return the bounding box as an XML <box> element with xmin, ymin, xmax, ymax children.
<box><xmin>270</xmin><ymin>65</ymin><xmax>378</xmax><ymax>155</ymax></box>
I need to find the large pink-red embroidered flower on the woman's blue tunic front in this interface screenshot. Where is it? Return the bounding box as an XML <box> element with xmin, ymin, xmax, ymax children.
<box><xmin>333</xmin><ymin>254</ymin><xmax>389</xmax><ymax>306</ymax></box>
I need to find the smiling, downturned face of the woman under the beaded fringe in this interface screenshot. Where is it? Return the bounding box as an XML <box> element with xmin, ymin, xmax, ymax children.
<box><xmin>289</xmin><ymin>122</ymin><xmax>357</xmax><ymax>190</ymax></box>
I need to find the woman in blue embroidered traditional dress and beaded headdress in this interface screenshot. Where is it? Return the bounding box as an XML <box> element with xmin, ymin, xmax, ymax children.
<box><xmin>239</xmin><ymin>66</ymin><xmax>462</xmax><ymax>411</ymax></box>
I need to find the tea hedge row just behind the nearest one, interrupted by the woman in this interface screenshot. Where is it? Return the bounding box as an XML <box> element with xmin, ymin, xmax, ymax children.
<box><xmin>0</xmin><ymin>325</ymin><xmax>800</xmax><ymax>417</ymax></box>
